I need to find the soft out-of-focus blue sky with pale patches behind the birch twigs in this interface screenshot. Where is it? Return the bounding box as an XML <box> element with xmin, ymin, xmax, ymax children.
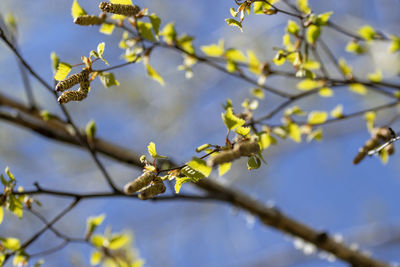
<box><xmin>0</xmin><ymin>0</ymin><xmax>400</xmax><ymax>267</ymax></box>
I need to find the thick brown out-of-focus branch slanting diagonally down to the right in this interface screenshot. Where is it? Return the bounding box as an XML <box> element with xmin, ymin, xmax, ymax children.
<box><xmin>0</xmin><ymin>92</ymin><xmax>387</xmax><ymax>266</ymax></box>
